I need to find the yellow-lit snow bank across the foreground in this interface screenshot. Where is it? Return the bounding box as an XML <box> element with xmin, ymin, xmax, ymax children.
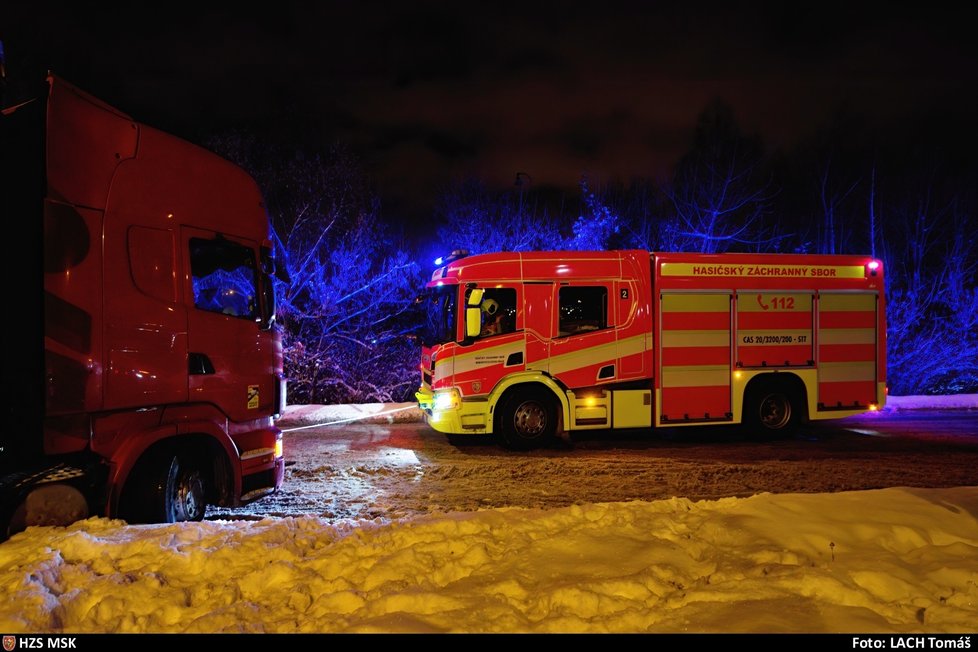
<box><xmin>0</xmin><ymin>487</ymin><xmax>978</xmax><ymax>633</ymax></box>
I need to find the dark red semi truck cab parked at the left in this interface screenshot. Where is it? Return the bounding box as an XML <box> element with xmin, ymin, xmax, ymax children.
<box><xmin>0</xmin><ymin>75</ymin><xmax>285</xmax><ymax>533</ymax></box>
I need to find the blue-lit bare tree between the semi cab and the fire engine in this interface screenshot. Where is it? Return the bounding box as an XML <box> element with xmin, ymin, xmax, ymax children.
<box><xmin>212</xmin><ymin>135</ymin><xmax>423</xmax><ymax>403</ymax></box>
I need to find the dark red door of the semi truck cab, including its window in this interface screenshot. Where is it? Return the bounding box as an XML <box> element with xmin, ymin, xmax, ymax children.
<box><xmin>182</xmin><ymin>227</ymin><xmax>277</xmax><ymax>422</ymax></box>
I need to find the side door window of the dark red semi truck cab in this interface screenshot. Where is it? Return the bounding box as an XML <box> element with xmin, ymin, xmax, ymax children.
<box><xmin>190</xmin><ymin>238</ymin><xmax>258</xmax><ymax>319</ymax></box>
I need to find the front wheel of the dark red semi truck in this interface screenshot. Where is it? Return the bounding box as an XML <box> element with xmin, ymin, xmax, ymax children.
<box><xmin>123</xmin><ymin>451</ymin><xmax>207</xmax><ymax>523</ymax></box>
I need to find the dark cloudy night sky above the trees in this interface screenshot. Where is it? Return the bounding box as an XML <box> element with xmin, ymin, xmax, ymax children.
<box><xmin>0</xmin><ymin>0</ymin><xmax>978</xmax><ymax>224</ymax></box>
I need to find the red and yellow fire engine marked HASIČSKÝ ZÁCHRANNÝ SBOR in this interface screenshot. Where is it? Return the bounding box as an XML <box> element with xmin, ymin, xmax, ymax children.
<box><xmin>417</xmin><ymin>251</ymin><xmax>886</xmax><ymax>448</ymax></box>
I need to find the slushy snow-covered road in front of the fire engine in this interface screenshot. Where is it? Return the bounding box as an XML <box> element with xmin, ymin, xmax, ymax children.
<box><xmin>207</xmin><ymin>410</ymin><xmax>978</xmax><ymax>519</ymax></box>
